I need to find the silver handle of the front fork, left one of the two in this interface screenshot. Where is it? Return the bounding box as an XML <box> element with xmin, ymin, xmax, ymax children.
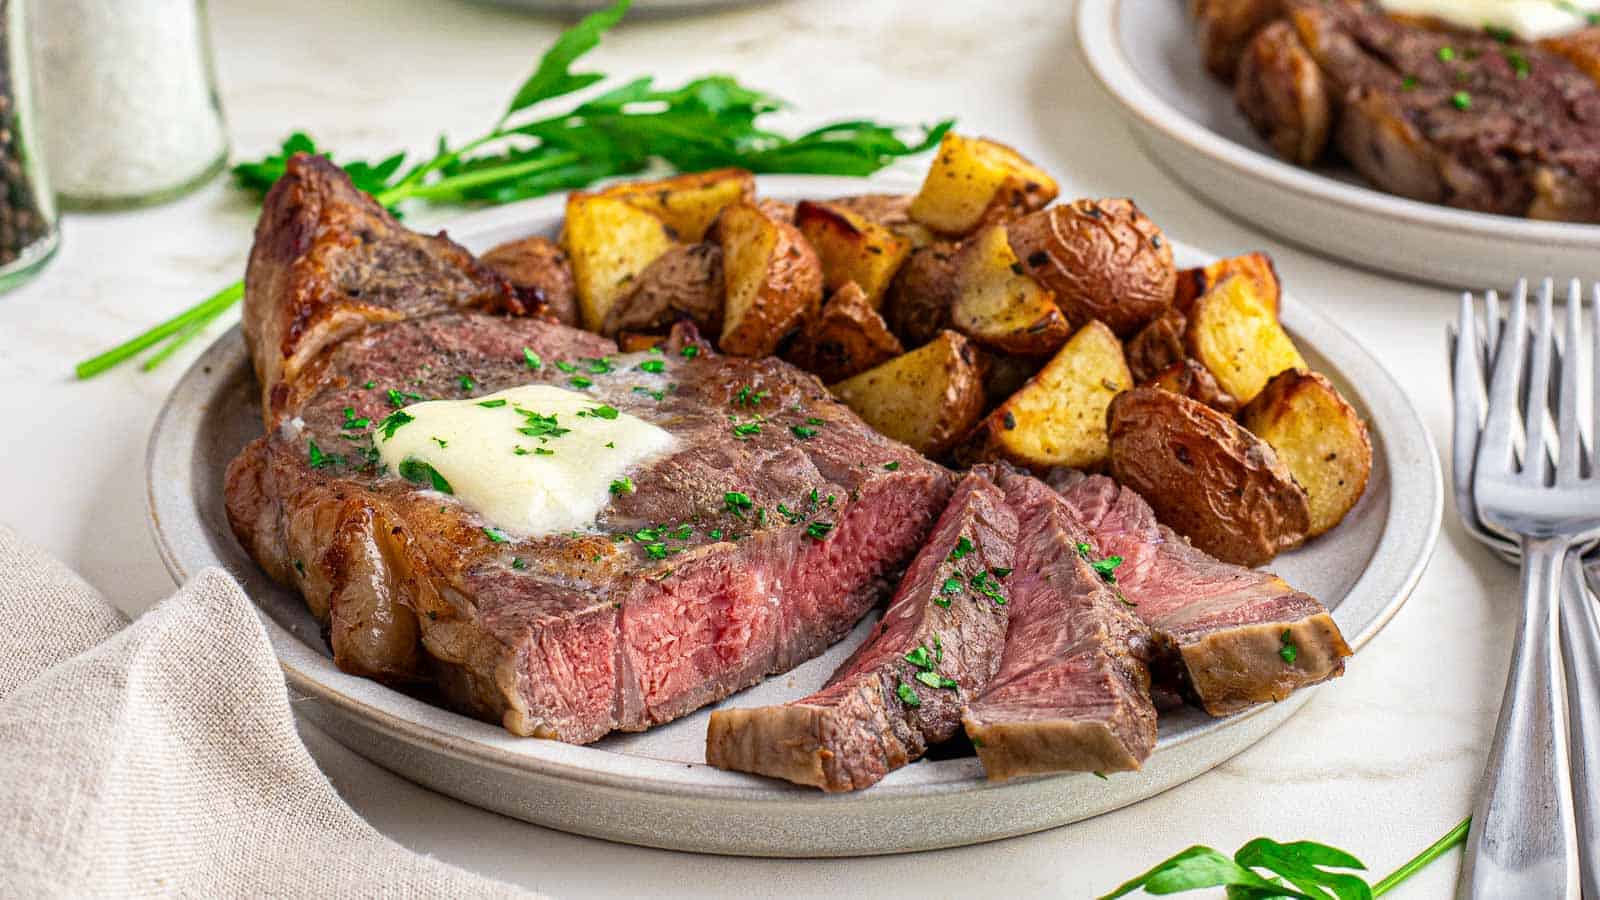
<box><xmin>1461</xmin><ymin>538</ymin><xmax>1578</xmax><ymax>900</ymax></box>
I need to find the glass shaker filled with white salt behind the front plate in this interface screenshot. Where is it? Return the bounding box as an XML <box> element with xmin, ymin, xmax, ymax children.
<box><xmin>29</xmin><ymin>0</ymin><xmax>227</xmax><ymax>210</ymax></box>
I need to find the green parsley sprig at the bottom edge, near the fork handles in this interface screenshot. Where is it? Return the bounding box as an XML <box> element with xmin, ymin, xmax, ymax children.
<box><xmin>1099</xmin><ymin>818</ymin><xmax>1472</xmax><ymax>900</ymax></box>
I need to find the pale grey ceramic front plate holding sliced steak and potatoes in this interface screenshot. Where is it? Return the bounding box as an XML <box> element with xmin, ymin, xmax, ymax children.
<box><xmin>147</xmin><ymin>178</ymin><xmax>1442</xmax><ymax>857</ymax></box>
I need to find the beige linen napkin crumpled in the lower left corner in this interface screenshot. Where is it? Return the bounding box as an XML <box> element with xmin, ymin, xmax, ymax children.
<box><xmin>0</xmin><ymin>525</ymin><xmax>537</xmax><ymax>897</ymax></box>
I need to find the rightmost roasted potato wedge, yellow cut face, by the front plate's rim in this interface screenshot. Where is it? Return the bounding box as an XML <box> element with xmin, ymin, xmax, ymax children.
<box><xmin>1238</xmin><ymin>368</ymin><xmax>1373</xmax><ymax>536</ymax></box>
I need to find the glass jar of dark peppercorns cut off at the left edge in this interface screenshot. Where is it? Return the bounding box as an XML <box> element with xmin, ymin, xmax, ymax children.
<box><xmin>0</xmin><ymin>0</ymin><xmax>61</xmax><ymax>290</ymax></box>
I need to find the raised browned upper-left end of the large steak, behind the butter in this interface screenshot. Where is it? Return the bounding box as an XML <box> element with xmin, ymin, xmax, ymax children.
<box><xmin>243</xmin><ymin>154</ymin><xmax>528</xmax><ymax>429</ymax></box>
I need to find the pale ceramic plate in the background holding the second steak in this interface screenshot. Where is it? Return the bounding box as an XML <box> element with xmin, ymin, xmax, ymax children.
<box><xmin>1077</xmin><ymin>0</ymin><xmax>1600</xmax><ymax>288</ymax></box>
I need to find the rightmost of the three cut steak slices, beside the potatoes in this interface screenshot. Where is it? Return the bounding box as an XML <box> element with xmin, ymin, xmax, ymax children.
<box><xmin>1049</xmin><ymin>472</ymin><xmax>1350</xmax><ymax>716</ymax></box>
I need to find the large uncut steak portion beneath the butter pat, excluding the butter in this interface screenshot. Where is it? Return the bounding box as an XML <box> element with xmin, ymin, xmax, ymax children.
<box><xmin>226</xmin><ymin>155</ymin><xmax>952</xmax><ymax>743</ymax></box>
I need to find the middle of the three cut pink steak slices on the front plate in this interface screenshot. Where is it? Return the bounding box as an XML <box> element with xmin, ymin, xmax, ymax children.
<box><xmin>963</xmin><ymin>472</ymin><xmax>1155</xmax><ymax>781</ymax></box>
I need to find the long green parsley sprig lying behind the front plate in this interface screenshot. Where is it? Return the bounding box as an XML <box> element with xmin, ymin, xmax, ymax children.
<box><xmin>75</xmin><ymin>0</ymin><xmax>954</xmax><ymax>378</ymax></box>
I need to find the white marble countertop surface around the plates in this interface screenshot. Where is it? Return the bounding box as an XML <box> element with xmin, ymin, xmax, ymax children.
<box><xmin>0</xmin><ymin>0</ymin><xmax>1517</xmax><ymax>898</ymax></box>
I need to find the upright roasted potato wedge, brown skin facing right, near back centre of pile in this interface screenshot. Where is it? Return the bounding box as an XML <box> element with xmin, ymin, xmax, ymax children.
<box><xmin>717</xmin><ymin>200</ymin><xmax>822</xmax><ymax>357</ymax></box>
